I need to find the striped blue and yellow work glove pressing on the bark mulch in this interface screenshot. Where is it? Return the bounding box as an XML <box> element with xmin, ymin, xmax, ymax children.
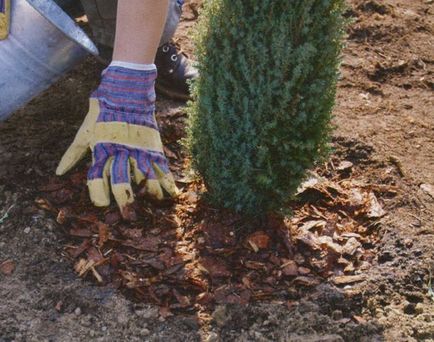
<box><xmin>56</xmin><ymin>66</ymin><xmax>178</xmax><ymax>213</ymax></box>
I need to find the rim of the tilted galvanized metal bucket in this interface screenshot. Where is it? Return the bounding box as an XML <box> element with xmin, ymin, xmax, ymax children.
<box><xmin>26</xmin><ymin>0</ymin><xmax>99</xmax><ymax>56</ymax></box>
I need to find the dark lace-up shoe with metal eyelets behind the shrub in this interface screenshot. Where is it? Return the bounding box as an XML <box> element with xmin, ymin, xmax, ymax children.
<box><xmin>155</xmin><ymin>43</ymin><xmax>199</xmax><ymax>101</ymax></box>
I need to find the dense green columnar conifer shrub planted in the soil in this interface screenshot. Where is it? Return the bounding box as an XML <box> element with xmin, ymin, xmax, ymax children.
<box><xmin>188</xmin><ymin>0</ymin><xmax>345</xmax><ymax>215</ymax></box>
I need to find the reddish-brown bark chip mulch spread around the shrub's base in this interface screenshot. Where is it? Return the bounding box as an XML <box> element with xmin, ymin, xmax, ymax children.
<box><xmin>36</xmin><ymin>146</ymin><xmax>396</xmax><ymax>316</ymax></box>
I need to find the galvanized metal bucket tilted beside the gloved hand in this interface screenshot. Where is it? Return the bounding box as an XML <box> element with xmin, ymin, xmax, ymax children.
<box><xmin>0</xmin><ymin>0</ymin><xmax>98</xmax><ymax>121</ymax></box>
